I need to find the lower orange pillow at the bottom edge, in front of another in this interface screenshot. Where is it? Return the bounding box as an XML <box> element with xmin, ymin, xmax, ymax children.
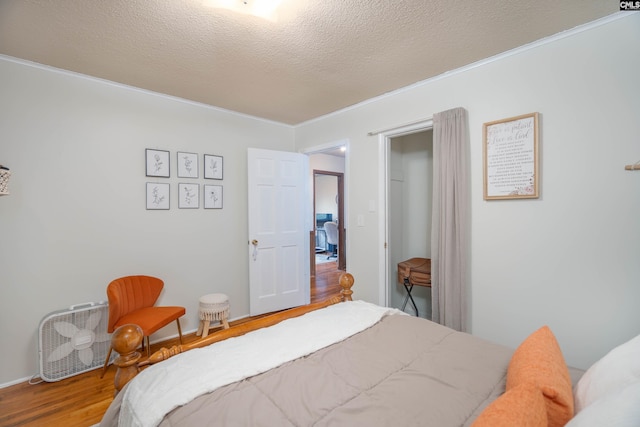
<box><xmin>471</xmin><ymin>383</ymin><xmax>548</xmax><ymax>427</ymax></box>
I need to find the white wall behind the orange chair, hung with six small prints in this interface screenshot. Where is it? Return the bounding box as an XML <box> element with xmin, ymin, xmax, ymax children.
<box><xmin>0</xmin><ymin>57</ymin><xmax>293</xmax><ymax>384</ymax></box>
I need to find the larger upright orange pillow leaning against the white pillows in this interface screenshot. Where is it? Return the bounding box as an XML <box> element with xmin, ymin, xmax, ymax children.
<box><xmin>506</xmin><ymin>326</ymin><xmax>573</xmax><ymax>427</ymax></box>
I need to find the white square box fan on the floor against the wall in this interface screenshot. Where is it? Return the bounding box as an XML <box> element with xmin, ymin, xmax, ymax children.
<box><xmin>38</xmin><ymin>301</ymin><xmax>115</xmax><ymax>382</ymax></box>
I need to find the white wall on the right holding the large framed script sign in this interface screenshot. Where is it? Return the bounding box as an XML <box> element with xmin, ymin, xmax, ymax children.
<box><xmin>295</xmin><ymin>13</ymin><xmax>640</xmax><ymax>367</ymax></box>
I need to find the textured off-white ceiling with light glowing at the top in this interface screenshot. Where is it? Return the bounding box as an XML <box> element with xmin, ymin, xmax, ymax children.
<box><xmin>0</xmin><ymin>0</ymin><xmax>619</xmax><ymax>124</ymax></box>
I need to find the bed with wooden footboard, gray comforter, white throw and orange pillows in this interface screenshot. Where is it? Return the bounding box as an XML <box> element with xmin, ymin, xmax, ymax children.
<box><xmin>100</xmin><ymin>274</ymin><xmax>640</xmax><ymax>427</ymax></box>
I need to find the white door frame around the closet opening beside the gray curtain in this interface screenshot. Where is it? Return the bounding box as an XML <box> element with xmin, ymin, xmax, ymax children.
<box><xmin>377</xmin><ymin>118</ymin><xmax>433</xmax><ymax>307</ymax></box>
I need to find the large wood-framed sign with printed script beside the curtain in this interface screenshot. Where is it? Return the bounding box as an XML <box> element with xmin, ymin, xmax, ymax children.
<box><xmin>482</xmin><ymin>113</ymin><xmax>539</xmax><ymax>200</ymax></box>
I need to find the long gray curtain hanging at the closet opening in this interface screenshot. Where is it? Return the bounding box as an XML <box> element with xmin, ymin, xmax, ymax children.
<box><xmin>431</xmin><ymin>108</ymin><xmax>470</xmax><ymax>332</ymax></box>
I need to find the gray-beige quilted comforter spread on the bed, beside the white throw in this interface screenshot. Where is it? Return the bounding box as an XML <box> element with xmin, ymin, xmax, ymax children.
<box><xmin>101</xmin><ymin>315</ymin><xmax>512</xmax><ymax>427</ymax></box>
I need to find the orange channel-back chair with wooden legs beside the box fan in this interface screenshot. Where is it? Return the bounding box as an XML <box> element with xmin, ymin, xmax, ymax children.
<box><xmin>102</xmin><ymin>276</ymin><xmax>186</xmax><ymax>376</ymax></box>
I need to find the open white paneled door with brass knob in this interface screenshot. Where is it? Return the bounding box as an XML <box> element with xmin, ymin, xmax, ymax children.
<box><xmin>247</xmin><ymin>148</ymin><xmax>310</xmax><ymax>316</ymax></box>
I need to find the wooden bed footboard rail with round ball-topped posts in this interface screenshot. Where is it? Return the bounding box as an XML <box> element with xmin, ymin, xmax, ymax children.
<box><xmin>111</xmin><ymin>273</ymin><xmax>354</xmax><ymax>394</ymax></box>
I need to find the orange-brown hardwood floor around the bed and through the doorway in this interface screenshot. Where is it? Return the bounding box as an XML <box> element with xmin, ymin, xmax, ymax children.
<box><xmin>0</xmin><ymin>262</ymin><xmax>343</xmax><ymax>427</ymax></box>
